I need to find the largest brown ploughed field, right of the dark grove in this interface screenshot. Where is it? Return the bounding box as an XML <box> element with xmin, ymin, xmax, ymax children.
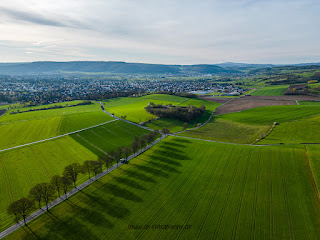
<box><xmin>216</xmin><ymin>96</ymin><xmax>297</xmax><ymax>114</ymax></box>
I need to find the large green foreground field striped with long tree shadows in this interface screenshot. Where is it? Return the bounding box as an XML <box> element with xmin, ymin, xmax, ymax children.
<box><xmin>6</xmin><ymin>137</ymin><xmax>320</xmax><ymax>240</ymax></box>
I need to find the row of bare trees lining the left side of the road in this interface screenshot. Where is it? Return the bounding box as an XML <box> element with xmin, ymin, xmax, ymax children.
<box><xmin>7</xmin><ymin>132</ymin><xmax>159</xmax><ymax>222</ymax></box>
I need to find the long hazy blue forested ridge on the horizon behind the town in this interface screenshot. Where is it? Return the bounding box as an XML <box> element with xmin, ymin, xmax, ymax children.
<box><xmin>0</xmin><ymin>61</ymin><xmax>238</xmax><ymax>74</ymax></box>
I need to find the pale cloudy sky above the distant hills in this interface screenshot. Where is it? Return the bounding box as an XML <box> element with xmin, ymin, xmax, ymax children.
<box><xmin>0</xmin><ymin>0</ymin><xmax>320</xmax><ymax>64</ymax></box>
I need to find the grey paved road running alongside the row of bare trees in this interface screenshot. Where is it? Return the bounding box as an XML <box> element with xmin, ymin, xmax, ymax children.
<box><xmin>0</xmin><ymin>135</ymin><xmax>167</xmax><ymax>239</ymax></box>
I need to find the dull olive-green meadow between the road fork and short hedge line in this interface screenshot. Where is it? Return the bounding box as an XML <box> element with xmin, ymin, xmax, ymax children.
<box><xmin>179</xmin><ymin>115</ymin><xmax>271</xmax><ymax>144</ymax></box>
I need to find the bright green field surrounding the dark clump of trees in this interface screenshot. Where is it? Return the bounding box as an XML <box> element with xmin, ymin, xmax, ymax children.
<box><xmin>104</xmin><ymin>94</ymin><xmax>220</xmax><ymax>132</ymax></box>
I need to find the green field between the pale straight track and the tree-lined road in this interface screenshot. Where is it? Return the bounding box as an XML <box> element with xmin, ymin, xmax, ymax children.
<box><xmin>0</xmin><ymin>120</ymin><xmax>146</xmax><ymax>230</ymax></box>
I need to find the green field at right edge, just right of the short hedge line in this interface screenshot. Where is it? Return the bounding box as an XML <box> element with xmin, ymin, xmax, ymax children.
<box><xmin>258</xmin><ymin>115</ymin><xmax>320</xmax><ymax>144</ymax></box>
